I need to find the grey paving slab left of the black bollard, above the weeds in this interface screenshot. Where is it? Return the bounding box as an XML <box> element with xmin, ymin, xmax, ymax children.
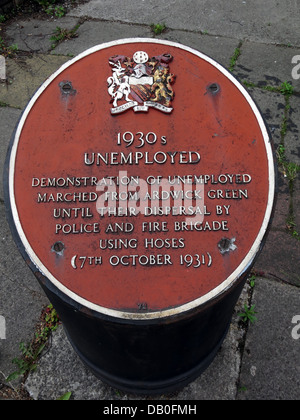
<box><xmin>0</xmin><ymin>203</ymin><xmax>49</xmax><ymax>383</ymax></box>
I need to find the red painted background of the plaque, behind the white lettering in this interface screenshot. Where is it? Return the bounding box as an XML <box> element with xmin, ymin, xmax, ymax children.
<box><xmin>14</xmin><ymin>43</ymin><xmax>269</xmax><ymax>311</ymax></box>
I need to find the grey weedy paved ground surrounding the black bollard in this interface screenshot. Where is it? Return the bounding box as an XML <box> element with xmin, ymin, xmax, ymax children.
<box><xmin>0</xmin><ymin>0</ymin><xmax>300</xmax><ymax>401</ymax></box>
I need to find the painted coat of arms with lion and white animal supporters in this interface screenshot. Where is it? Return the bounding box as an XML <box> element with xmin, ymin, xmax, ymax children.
<box><xmin>107</xmin><ymin>51</ymin><xmax>175</xmax><ymax>115</ymax></box>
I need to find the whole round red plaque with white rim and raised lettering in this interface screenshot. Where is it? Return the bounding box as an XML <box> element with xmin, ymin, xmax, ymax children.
<box><xmin>9</xmin><ymin>39</ymin><xmax>275</xmax><ymax>319</ymax></box>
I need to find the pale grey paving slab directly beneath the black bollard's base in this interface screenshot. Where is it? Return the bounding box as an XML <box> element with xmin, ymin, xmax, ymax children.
<box><xmin>25</xmin><ymin>284</ymin><xmax>249</xmax><ymax>401</ymax></box>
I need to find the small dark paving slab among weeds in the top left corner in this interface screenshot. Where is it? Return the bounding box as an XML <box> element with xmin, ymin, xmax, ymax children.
<box><xmin>5</xmin><ymin>16</ymin><xmax>78</xmax><ymax>53</ymax></box>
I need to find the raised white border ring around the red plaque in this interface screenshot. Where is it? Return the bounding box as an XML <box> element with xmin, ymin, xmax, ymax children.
<box><xmin>9</xmin><ymin>38</ymin><xmax>275</xmax><ymax>320</ymax></box>
